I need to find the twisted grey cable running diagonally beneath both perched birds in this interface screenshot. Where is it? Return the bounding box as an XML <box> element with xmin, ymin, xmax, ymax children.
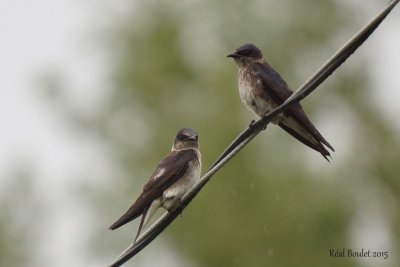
<box><xmin>109</xmin><ymin>0</ymin><xmax>400</xmax><ymax>267</ymax></box>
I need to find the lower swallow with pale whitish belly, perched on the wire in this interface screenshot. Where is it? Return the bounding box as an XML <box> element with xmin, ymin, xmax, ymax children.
<box><xmin>109</xmin><ymin>128</ymin><xmax>201</xmax><ymax>242</ymax></box>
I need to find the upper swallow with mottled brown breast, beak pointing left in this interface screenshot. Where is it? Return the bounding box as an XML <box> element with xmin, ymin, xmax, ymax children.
<box><xmin>228</xmin><ymin>44</ymin><xmax>334</xmax><ymax>161</ymax></box>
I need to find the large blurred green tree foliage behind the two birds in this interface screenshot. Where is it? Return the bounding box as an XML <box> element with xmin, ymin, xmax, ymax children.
<box><xmin>0</xmin><ymin>0</ymin><xmax>400</xmax><ymax>266</ymax></box>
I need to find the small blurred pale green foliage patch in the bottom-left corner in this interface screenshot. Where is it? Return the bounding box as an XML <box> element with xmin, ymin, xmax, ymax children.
<box><xmin>0</xmin><ymin>166</ymin><xmax>46</xmax><ymax>266</ymax></box>
